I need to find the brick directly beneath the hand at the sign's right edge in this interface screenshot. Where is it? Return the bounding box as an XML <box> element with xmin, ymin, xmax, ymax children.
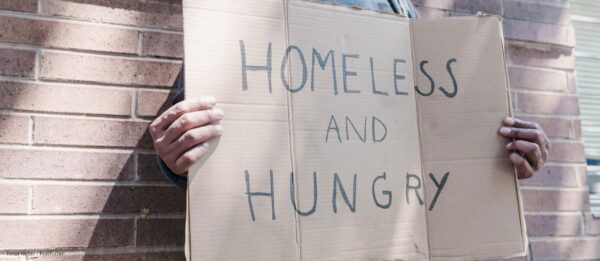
<box><xmin>520</xmin><ymin>166</ymin><xmax>585</xmax><ymax>188</ymax></box>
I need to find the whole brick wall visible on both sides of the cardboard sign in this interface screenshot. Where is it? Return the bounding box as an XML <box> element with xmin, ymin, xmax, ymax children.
<box><xmin>0</xmin><ymin>0</ymin><xmax>600</xmax><ymax>260</ymax></box>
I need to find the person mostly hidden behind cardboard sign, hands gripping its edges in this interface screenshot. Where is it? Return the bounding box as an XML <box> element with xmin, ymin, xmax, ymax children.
<box><xmin>149</xmin><ymin>0</ymin><xmax>550</xmax><ymax>187</ymax></box>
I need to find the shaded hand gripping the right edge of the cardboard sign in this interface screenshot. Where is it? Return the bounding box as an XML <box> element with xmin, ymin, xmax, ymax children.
<box><xmin>500</xmin><ymin>118</ymin><xmax>550</xmax><ymax>179</ymax></box>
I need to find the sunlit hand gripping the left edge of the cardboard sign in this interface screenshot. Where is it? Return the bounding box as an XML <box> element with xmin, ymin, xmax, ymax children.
<box><xmin>149</xmin><ymin>97</ymin><xmax>223</xmax><ymax>176</ymax></box>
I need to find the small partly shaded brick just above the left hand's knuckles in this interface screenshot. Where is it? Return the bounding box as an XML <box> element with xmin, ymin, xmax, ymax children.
<box><xmin>137</xmin><ymin>91</ymin><xmax>175</xmax><ymax>117</ymax></box>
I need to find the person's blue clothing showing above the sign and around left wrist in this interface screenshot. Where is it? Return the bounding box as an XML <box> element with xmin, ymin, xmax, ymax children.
<box><xmin>157</xmin><ymin>0</ymin><xmax>420</xmax><ymax>188</ymax></box>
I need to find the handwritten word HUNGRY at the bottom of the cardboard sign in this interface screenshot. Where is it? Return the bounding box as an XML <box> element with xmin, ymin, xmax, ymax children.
<box><xmin>244</xmin><ymin>170</ymin><xmax>450</xmax><ymax>221</ymax></box>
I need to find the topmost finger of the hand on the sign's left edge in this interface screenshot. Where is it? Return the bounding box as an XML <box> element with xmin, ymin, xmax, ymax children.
<box><xmin>150</xmin><ymin>96</ymin><xmax>217</xmax><ymax>136</ymax></box>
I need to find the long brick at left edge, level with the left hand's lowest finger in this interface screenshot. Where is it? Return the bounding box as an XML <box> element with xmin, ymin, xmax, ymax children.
<box><xmin>0</xmin><ymin>149</ymin><xmax>135</xmax><ymax>180</ymax></box>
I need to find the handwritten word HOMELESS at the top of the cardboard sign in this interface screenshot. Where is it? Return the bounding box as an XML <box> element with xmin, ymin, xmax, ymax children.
<box><xmin>240</xmin><ymin>40</ymin><xmax>458</xmax><ymax>98</ymax></box>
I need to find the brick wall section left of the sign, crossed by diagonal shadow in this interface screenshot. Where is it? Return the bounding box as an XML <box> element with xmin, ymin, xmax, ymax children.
<box><xmin>0</xmin><ymin>0</ymin><xmax>185</xmax><ymax>260</ymax></box>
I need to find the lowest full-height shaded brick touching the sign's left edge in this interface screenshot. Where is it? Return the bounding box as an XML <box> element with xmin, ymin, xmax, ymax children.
<box><xmin>136</xmin><ymin>218</ymin><xmax>185</xmax><ymax>246</ymax></box>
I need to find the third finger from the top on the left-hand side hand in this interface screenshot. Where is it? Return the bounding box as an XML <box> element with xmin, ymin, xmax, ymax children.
<box><xmin>169</xmin><ymin>124</ymin><xmax>223</xmax><ymax>159</ymax></box>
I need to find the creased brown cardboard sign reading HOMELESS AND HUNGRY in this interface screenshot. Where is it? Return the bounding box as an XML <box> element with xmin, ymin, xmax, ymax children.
<box><xmin>183</xmin><ymin>0</ymin><xmax>527</xmax><ymax>260</ymax></box>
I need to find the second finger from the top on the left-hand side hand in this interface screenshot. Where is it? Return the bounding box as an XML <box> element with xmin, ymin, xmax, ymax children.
<box><xmin>163</xmin><ymin>109</ymin><xmax>224</xmax><ymax>144</ymax></box>
